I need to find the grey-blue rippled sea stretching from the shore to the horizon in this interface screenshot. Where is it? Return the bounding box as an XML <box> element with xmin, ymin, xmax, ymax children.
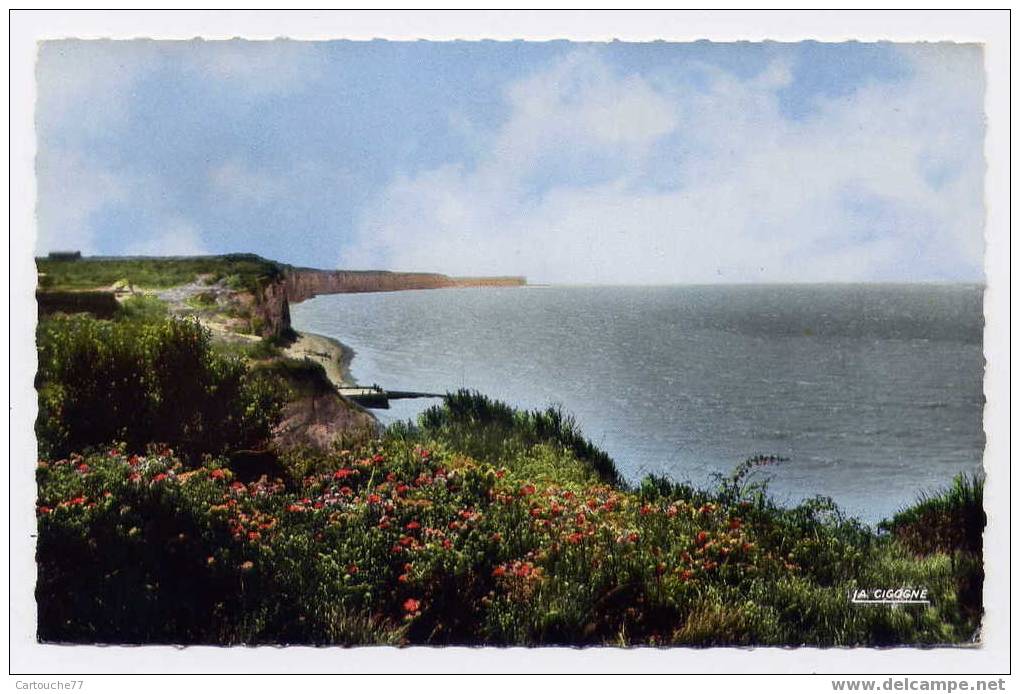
<box><xmin>292</xmin><ymin>285</ymin><xmax>984</xmax><ymax>522</ymax></box>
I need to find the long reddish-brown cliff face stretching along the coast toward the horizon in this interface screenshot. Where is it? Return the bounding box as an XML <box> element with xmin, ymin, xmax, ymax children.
<box><xmin>255</xmin><ymin>267</ymin><xmax>527</xmax><ymax>336</ymax></box>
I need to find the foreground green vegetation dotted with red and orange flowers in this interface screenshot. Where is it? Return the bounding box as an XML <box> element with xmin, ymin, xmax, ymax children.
<box><xmin>38</xmin><ymin>412</ymin><xmax>980</xmax><ymax>645</ymax></box>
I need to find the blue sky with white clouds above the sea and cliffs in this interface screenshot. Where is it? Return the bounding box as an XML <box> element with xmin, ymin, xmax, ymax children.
<box><xmin>36</xmin><ymin>40</ymin><xmax>984</xmax><ymax>284</ymax></box>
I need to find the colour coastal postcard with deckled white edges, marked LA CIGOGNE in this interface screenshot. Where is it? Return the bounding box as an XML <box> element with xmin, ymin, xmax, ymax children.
<box><xmin>11</xmin><ymin>13</ymin><xmax>1008</xmax><ymax>672</ymax></box>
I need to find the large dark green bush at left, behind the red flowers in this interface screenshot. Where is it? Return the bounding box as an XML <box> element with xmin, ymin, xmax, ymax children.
<box><xmin>36</xmin><ymin>316</ymin><xmax>282</xmax><ymax>461</ymax></box>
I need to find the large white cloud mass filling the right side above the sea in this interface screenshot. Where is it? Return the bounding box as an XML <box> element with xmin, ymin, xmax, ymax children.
<box><xmin>341</xmin><ymin>48</ymin><xmax>983</xmax><ymax>283</ymax></box>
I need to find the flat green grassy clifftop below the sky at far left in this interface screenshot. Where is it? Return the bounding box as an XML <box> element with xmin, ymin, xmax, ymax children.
<box><xmin>36</xmin><ymin>253</ymin><xmax>283</xmax><ymax>291</ymax></box>
